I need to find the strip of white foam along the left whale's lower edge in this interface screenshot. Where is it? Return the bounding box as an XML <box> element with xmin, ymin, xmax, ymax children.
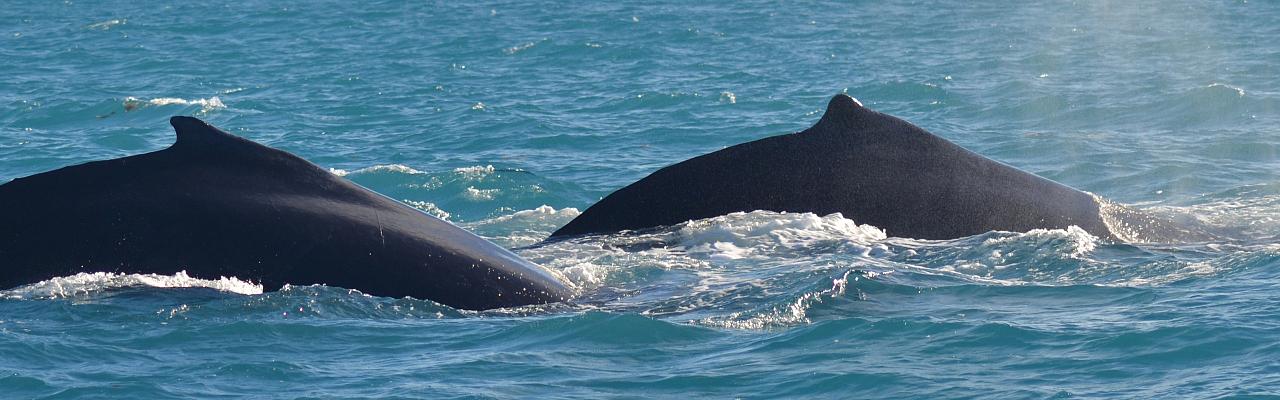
<box><xmin>0</xmin><ymin>271</ymin><xmax>262</xmax><ymax>299</ymax></box>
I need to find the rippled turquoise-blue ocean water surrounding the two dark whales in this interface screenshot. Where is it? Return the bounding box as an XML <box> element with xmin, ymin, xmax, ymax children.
<box><xmin>0</xmin><ymin>0</ymin><xmax>1280</xmax><ymax>399</ymax></box>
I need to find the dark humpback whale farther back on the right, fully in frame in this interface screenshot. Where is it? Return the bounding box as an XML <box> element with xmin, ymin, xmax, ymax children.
<box><xmin>550</xmin><ymin>94</ymin><xmax>1207</xmax><ymax>241</ymax></box>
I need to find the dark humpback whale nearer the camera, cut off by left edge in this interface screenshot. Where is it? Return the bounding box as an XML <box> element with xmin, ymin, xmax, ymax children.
<box><xmin>0</xmin><ymin>117</ymin><xmax>571</xmax><ymax>310</ymax></box>
